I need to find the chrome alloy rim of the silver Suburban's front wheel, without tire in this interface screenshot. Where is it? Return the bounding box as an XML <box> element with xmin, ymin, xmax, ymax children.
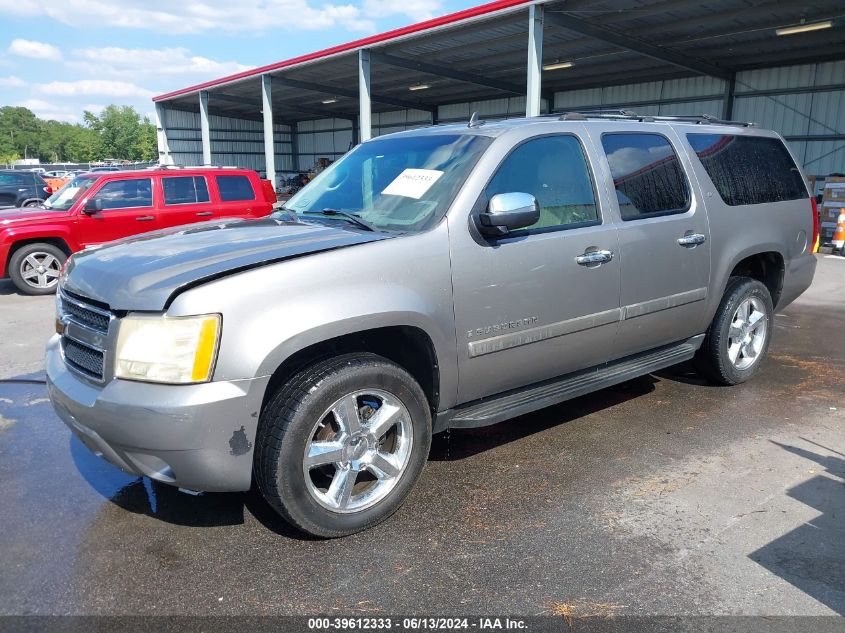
<box><xmin>302</xmin><ymin>389</ymin><xmax>413</xmax><ymax>513</ymax></box>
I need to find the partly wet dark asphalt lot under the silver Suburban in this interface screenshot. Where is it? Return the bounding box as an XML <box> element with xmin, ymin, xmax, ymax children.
<box><xmin>0</xmin><ymin>256</ymin><xmax>845</xmax><ymax>615</ymax></box>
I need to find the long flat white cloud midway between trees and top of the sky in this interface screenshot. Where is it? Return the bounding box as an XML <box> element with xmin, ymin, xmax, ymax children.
<box><xmin>67</xmin><ymin>46</ymin><xmax>251</xmax><ymax>77</ymax></box>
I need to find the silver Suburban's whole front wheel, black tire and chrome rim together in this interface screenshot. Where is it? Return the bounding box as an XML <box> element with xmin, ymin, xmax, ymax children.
<box><xmin>255</xmin><ymin>354</ymin><xmax>431</xmax><ymax>538</ymax></box>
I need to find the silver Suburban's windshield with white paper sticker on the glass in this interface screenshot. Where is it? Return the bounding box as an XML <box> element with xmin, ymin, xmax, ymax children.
<box><xmin>285</xmin><ymin>134</ymin><xmax>491</xmax><ymax>232</ymax></box>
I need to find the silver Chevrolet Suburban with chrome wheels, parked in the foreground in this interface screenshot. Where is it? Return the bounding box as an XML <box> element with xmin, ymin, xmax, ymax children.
<box><xmin>47</xmin><ymin>113</ymin><xmax>818</xmax><ymax>537</ymax></box>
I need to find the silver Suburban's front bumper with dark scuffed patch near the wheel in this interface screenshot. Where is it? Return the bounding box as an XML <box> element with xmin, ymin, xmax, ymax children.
<box><xmin>46</xmin><ymin>336</ymin><xmax>269</xmax><ymax>492</ymax></box>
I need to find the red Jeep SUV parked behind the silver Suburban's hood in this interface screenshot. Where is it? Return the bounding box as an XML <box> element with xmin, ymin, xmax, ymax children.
<box><xmin>0</xmin><ymin>167</ymin><xmax>276</xmax><ymax>295</ymax></box>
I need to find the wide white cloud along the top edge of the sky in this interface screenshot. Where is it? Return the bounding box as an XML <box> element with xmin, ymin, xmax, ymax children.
<box><xmin>0</xmin><ymin>0</ymin><xmax>378</xmax><ymax>34</ymax></box>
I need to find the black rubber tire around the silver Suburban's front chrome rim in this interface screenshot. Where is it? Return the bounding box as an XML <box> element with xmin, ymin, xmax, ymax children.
<box><xmin>254</xmin><ymin>353</ymin><xmax>431</xmax><ymax>538</ymax></box>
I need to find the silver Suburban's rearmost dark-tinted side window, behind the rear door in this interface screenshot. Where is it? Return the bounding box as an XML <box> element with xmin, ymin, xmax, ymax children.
<box><xmin>687</xmin><ymin>134</ymin><xmax>809</xmax><ymax>206</ymax></box>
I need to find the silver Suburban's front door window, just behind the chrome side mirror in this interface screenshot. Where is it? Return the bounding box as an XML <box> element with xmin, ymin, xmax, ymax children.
<box><xmin>485</xmin><ymin>135</ymin><xmax>599</xmax><ymax>235</ymax></box>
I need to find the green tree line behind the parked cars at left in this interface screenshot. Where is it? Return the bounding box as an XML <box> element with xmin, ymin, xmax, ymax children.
<box><xmin>0</xmin><ymin>105</ymin><xmax>158</xmax><ymax>165</ymax></box>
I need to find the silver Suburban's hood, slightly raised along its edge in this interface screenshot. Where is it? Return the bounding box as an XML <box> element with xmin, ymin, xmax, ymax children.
<box><xmin>62</xmin><ymin>217</ymin><xmax>392</xmax><ymax>311</ymax></box>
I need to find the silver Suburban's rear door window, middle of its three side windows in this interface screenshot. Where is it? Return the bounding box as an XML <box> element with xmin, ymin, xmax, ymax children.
<box><xmin>601</xmin><ymin>133</ymin><xmax>690</xmax><ymax>220</ymax></box>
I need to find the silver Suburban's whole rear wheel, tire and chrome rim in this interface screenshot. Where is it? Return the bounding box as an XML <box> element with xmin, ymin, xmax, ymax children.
<box><xmin>696</xmin><ymin>277</ymin><xmax>774</xmax><ymax>385</ymax></box>
